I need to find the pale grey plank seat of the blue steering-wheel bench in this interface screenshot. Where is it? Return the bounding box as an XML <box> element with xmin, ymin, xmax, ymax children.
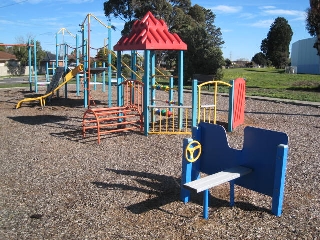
<box><xmin>183</xmin><ymin>166</ymin><xmax>252</xmax><ymax>193</ymax></box>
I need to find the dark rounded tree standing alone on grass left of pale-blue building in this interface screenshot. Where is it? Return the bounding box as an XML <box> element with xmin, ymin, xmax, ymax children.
<box><xmin>260</xmin><ymin>17</ymin><xmax>293</xmax><ymax>68</ymax></box>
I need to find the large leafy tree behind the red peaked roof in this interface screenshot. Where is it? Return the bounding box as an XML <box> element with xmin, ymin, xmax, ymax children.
<box><xmin>104</xmin><ymin>0</ymin><xmax>224</xmax><ymax>79</ymax></box>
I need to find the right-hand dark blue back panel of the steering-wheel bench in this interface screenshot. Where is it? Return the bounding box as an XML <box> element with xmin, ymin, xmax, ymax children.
<box><xmin>235</xmin><ymin>127</ymin><xmax>288</xmax><ymax>196</ymax></box>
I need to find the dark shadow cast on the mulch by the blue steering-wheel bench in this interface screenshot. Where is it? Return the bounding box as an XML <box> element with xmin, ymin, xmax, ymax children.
<box><xmin>92</xmin><ymin>168</ymin><xmax>271</xmax><ymax>214</ymax></box>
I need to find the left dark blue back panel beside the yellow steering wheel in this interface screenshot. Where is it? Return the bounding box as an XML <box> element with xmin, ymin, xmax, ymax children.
<box><xmin>199</xmin><ymin>122</ymin><xmax>241</xmax><ymax>174</ymax></box>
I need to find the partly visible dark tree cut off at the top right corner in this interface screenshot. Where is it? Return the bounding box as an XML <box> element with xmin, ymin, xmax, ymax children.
<box><xmin>306</xmin><ymin>0</ymin><xmax>320</xmax><ymax>55</ymax></box>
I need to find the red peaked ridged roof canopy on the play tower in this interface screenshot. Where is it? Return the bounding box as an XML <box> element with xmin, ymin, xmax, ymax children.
<box><xmin>113</xmin><ymin>12</ymin><xmax>187</xmax><ymax>51</ymax></box>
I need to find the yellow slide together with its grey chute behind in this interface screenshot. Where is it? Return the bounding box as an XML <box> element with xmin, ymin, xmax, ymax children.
<box><xmin>16</xmin><ymin>64</ymin><xmax>83</xmax><ymax>108</ymax></box>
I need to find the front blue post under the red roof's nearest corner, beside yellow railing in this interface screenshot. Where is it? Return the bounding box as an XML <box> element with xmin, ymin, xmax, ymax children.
<box><xmin>143</xmin><ymin>50</ymin><xmax>150</xmax><ymax>136</ymax></box>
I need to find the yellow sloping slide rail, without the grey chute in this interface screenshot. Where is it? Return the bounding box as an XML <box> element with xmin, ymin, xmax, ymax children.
<box><xmin>16</xmin><ymin>64</ymin><xmax>83</xmax><ymax>108</ymax></box>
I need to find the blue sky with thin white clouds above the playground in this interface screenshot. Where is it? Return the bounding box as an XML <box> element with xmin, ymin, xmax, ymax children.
<box><xmin>0</xmin><ymin>0</ymin><xmax>310</xmax><ymax>60</ymax></box>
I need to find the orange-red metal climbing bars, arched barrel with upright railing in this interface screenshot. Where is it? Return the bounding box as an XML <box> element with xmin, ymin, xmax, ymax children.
<box><xmin>82</xmin><ymin>80</ymin><xmax>143</xmax><ymax>143</ymax></box>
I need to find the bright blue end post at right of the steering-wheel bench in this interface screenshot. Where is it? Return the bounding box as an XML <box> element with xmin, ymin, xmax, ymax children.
<box><xmin>271</xmin><ymin>144</ymin><xmax>288</xmax><ymax>216</ymax></box>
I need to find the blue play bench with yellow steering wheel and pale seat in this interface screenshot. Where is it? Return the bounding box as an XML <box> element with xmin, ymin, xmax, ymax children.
<box><xmin>181</xmin><ymin>122</ymin><xmax>288</xmax><ymax>219</ymax></box>
